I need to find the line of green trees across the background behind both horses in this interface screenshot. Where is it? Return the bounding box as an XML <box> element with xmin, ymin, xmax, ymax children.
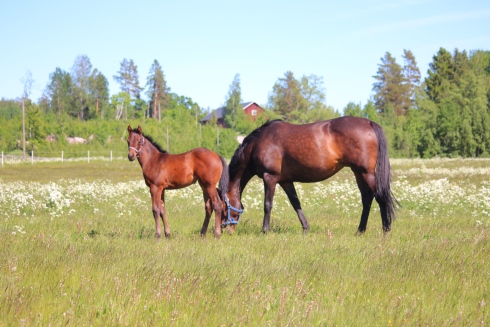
<box><xmin>0</xmin><ymin>48</ymin><xmax>490</xmax><ymax>158</ymax></box>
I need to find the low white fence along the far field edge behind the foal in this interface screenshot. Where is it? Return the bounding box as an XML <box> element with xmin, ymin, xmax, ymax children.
<box><xmin>1</xmin><ymin>150</ymin><xmax>127</xmax><ymax>167</ymax></box>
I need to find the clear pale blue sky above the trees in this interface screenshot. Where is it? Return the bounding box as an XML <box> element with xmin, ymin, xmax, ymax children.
<box><xmin>0</xmin><ymin>0</ymin><xmax>490</xmax><ymax>111</ymax></box>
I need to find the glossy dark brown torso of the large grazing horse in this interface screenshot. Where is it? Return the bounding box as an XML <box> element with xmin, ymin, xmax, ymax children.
<box><xmin>249</xmin><ymin>116</ymin><xmax>378</xmax><ymax>182</ymax></box>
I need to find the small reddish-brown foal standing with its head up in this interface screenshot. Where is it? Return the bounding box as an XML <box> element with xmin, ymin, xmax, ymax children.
<box><xmin>128</xmin><ymin>126</ymin><xmax>228</xmax><ymax>238</ymax></box>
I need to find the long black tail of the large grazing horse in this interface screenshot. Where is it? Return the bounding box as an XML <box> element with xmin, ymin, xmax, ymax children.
<box><xmin>371</xmin><ymin>122</ymin><xmax>399</xmax><ymax>231</ymax></box>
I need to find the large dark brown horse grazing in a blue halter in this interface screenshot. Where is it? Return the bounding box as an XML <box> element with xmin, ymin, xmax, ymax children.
<box><xmin>222</xmin><ymin>117</ymin><xmax>398</xmax><ymax>233</ymax></box>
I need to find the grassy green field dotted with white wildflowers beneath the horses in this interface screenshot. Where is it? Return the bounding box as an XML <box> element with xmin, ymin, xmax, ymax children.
<box><xmin>0</xmin><ymin>159</ymin><xmax>490</xmax><ymax>326</ymax></box>
